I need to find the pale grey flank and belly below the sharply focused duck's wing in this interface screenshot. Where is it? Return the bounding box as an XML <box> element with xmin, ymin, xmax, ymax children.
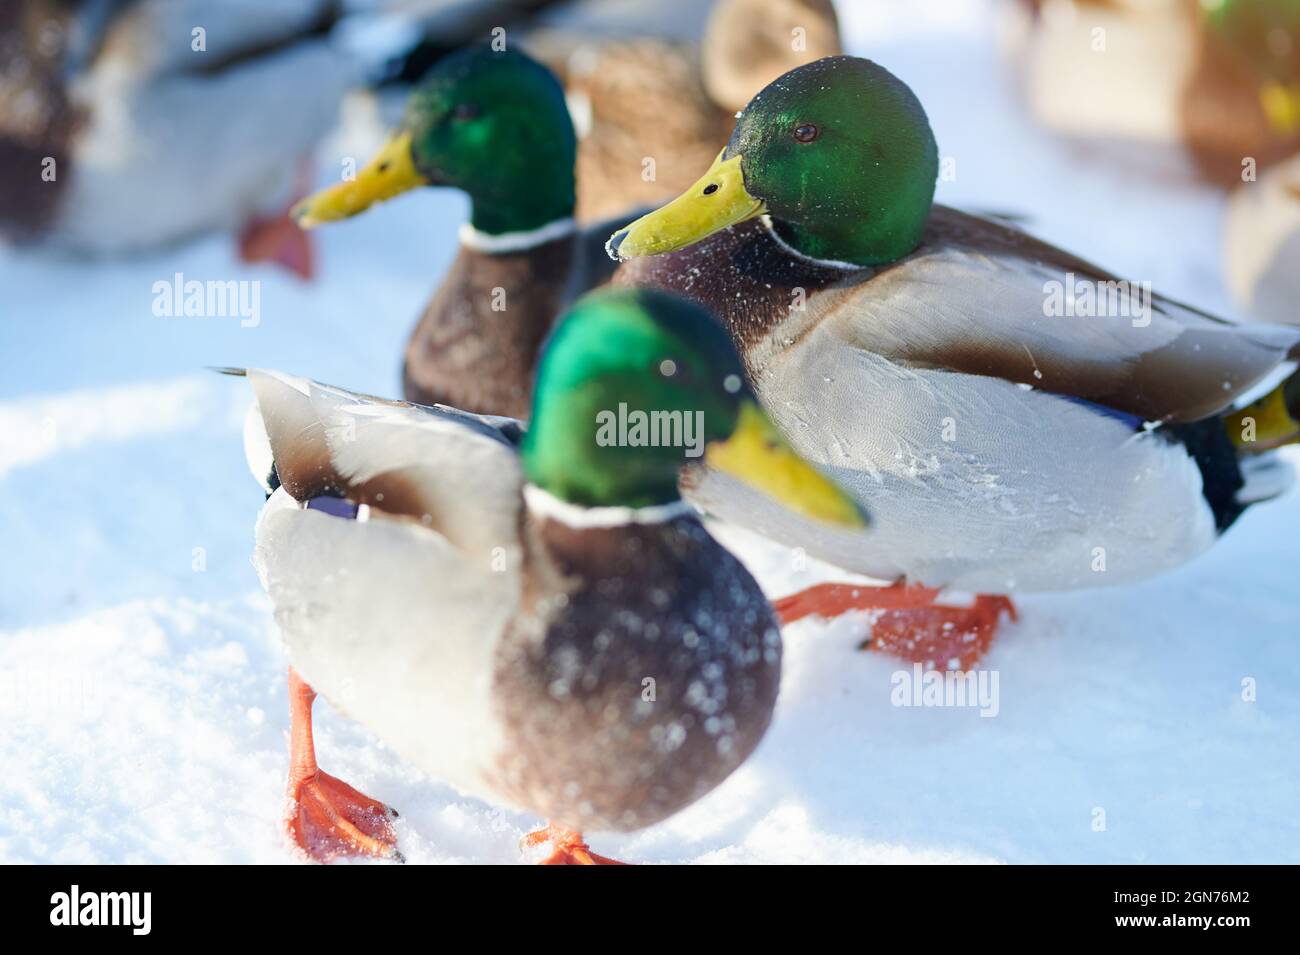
<box><xmin>692</xmin><ymin>343</ymin><xmax>1214</xmax><ymax>594</ymax></box>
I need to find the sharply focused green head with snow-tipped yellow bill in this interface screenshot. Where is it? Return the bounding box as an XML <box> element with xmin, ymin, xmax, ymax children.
<box><xmin>608</xmin><ymin>56</ymin><xmax>939</xmax><ymax>266</ymax></box>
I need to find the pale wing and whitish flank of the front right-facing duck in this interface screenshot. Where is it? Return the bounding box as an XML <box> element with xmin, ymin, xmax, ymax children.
<box><xmin>248</xmin><ymin>370</ymin><xmax>523</xmax><ymax>789</ymax></box>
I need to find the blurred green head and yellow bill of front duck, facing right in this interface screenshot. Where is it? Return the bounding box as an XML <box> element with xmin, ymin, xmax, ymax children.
<box><xmin>523</xmin><ymin>290</ymin><xmax>866</xmax><ymax>528</ymax></box>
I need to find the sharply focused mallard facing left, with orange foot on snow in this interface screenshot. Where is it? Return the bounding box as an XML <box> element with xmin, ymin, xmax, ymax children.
<box><xmin>610</xmin><ymin>56</ymin><xmax>1300</xmax><ymax>667</ymax></box>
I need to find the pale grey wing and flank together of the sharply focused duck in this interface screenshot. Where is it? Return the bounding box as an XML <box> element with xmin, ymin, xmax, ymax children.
<box><xmin>692</xmin><ymin>233</ymin><xmax>1296</xmax><ymax>592</ymax></box>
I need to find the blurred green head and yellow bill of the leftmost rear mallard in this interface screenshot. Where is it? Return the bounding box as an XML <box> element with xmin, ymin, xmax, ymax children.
<box><xmin>293</xmin><ymin>45</ymin><xmax>577</xmax><ymax>235</ymax></box>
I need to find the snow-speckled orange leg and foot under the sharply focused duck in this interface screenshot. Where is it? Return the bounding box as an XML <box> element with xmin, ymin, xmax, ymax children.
<box><xmin>772</xmin><ymin>581</ymin><xmax>1017</xmax><ymax>670</ymax></box>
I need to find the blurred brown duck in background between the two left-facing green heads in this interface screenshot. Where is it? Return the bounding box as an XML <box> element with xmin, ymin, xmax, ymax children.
<box><xmin>528</xmin><ymin>0</ymin><xmax>840</xmax><ymax>222</ymax></box>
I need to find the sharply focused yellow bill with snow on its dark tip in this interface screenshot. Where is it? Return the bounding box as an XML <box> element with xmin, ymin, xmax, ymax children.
<box><xmin>607</xmin><ymin>149</ymin><xmax>767</xmax><ymax>259</ymax></box>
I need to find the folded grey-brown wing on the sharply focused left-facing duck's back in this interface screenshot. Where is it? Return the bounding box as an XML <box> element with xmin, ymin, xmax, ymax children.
<box><xmin>820</xmin><ymin>207</ymin><xmax>1300</xmax><ymax>422</ymax></box>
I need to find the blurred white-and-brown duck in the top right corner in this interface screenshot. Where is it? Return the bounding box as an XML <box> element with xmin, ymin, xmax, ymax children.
<box><xmin>1006</xmin><ymin>0</ymin><xmax>1300</xmax><ymax>186</ymax></box>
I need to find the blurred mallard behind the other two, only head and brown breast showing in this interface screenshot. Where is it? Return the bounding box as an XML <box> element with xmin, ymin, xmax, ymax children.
<box><xmin>294</xmin><ymin>44</ymin><xmax>639</xmax><ymax>417</ymax></box>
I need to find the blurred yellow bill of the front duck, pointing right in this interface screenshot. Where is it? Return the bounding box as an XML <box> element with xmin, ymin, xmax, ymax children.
<box><xmin>705</xmin><ymin>401</ymin><xmax>867</xmax><ymax>528</ymax></box>
